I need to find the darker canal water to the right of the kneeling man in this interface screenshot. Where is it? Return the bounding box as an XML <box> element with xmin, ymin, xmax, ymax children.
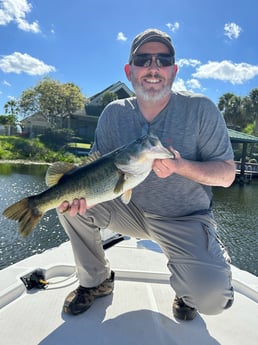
<box><xmin>213</xmin><ymin>183</ymin><xmax>258</xmax><ymax>276</ymax></box>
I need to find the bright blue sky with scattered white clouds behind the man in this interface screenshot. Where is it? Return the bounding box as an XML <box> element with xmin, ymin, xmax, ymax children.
<box><xmin>0</xmin><ymin>0</ymin><xmax>258</xmax><ymax>114</ymax></box>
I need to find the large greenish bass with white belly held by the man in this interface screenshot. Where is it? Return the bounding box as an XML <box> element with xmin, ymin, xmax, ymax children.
<box><xmin>3</xmin><ymin>134</ymin><xmax>175</xmax><ymax>237</ymax></box>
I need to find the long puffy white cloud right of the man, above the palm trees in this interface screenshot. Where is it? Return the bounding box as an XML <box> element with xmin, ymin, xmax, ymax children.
<box><xmin>193</xmin><ymin>60</ymin><xmax>258</xmax><ymax>84</ymax></box>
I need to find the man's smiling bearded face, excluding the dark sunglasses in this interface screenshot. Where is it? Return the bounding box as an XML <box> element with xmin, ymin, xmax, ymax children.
<box><xmin>125</xmin><ymin>42</ymin><xmax>177</xmax><ymax>102</ymax></box>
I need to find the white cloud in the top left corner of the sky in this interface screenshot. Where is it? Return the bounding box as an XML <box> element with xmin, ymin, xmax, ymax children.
<box><xmin>0</xmin><ymin>0</ymin><xmax>40</xmax><ymax>33</ymax></box>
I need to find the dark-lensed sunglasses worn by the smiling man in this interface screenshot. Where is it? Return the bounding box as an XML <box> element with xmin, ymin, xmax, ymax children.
<box><xmin>132</xmin><ymin>53</ymin><xmax>175</xmax><ymax>68</ymax></box>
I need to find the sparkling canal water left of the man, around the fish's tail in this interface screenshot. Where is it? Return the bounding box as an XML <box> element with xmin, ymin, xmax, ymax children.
<box><xmin>0</xmin><ymin>164</ymin><xmax>68</xmax><ymax>269</ymax></box>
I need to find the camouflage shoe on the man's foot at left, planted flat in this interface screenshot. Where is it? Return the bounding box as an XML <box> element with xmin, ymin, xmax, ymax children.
<box><xmin>63</xmin><ymin>271</ymin><xmax>115</xmax><ymax>315</ymax></box>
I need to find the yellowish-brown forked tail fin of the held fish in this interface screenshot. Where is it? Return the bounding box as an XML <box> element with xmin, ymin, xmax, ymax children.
<box><xmin>3</xmin><ymin>198</ymin><xmax>43</xmax><ymax>237</ymax></box>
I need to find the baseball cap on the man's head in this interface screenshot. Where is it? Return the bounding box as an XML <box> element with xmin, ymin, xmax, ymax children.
<box><xmin>129</xmin><ymin>29</ymin><xmax>175</xmax><ymax>63</ymax></box>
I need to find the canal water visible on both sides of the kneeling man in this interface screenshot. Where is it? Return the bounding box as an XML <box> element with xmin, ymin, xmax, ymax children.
<box><xmin>0</xmin><ymin>164</ymin><xmax>258</xmax><ymax>276</ymax></box>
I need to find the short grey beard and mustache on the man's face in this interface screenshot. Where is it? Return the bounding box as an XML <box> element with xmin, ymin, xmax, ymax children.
<box><xmin>131</xmin><ymin>74</ymin><xmax>173</xmax><ymax>103</ymax></box>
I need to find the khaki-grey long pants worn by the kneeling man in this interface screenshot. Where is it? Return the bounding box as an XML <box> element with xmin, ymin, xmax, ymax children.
<box><xmin>59</xmin><ymin>199</ymin><xmax>233</xmax><ymax>314</ymax></box>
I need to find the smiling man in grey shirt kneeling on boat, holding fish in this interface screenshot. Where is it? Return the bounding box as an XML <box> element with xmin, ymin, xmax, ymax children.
<box><xmin>58</xmin><ymin>29</ymin><xmax>235</xmax><ymax>320</ymax></box>
